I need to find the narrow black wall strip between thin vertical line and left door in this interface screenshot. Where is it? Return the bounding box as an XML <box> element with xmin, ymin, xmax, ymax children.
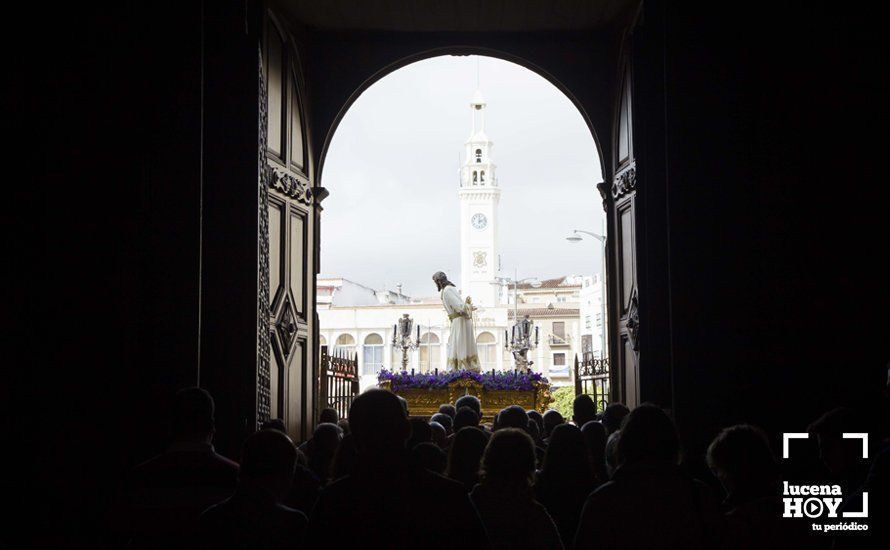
<box><xmin>200</xmin><ymin>2</ymin><xmax>265</xmax><ymax>458</ymax></box>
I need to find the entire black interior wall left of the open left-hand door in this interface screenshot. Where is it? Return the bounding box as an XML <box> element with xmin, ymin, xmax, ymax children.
<box><xmin>13</xmin><ymin>2</ymin><xmax>261</xmax><ymax>545</ymax></box>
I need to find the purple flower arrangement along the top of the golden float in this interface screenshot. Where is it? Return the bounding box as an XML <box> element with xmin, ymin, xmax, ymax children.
<box><xmin>377</xmin><ymin>369</ymin><xmax>550</xmax><ymax>391</ymax></box>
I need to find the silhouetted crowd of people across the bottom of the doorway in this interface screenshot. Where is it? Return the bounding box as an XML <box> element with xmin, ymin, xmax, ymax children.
<box><xmin>110</xmin><ymin>388</ymin><xmax>890</xmax><ymax>550</ymax></box>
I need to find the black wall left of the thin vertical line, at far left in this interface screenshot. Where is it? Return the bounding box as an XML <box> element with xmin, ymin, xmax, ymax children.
<box><xmin>13</xmin><ymin>2</ymin><xmax>207</xmax><ymax>545</ymax></box>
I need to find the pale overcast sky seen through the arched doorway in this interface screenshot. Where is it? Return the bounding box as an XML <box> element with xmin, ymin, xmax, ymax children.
<box><xmin>321</xmin><ymin>56</ymin><xmax>603</xmax><ymax>296</ymax></box>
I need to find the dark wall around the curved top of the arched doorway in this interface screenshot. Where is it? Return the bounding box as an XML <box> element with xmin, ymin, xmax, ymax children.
<box><xmin>294</xmin><ymin>29</ymin><xmax>617</xmax><ymax>185</ymax></box>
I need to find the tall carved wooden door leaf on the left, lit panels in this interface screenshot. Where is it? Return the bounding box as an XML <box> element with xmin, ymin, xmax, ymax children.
<box><xmin>259</xmin><ymin>14</ymin><xmax>317</xmax><ymax>441</ymax></box>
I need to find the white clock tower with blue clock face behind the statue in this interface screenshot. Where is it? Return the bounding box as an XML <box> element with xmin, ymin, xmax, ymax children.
<box><xmin>458</xmin><ymin>90</ymin><xmax>501</xmax><ymax>307</ymax></box>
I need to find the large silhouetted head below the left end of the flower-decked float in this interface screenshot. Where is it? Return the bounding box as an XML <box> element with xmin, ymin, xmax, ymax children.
<box><xmin>349</xmin><ymin>389</ymin><xmax>411</xmax><ymax>455</ymax></box>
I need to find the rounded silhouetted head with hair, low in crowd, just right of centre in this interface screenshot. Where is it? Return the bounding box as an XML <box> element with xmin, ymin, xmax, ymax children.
<box><xmin>480</xmin><ymin>428</ymin><xmax>535</xmax><ymax>488</ymax></box>
